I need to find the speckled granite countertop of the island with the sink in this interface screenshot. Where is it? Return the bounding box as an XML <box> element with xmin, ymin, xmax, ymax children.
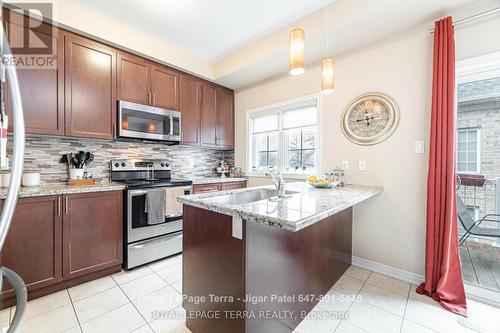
<box><xmin>177</xmin><ymin>182</ymin><xmax>383</xmax><ymax>231</ymax></box>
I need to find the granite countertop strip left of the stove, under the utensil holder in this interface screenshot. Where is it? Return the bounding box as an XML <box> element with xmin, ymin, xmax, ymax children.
<box><xmin>0</xmin><ymin>181</ymin><xmax>125</xmax><ymax>199</ymax></box>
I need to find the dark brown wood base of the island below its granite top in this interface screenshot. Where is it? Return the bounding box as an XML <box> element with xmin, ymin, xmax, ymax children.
<box><xmin>182</xmin><ymin>205</ymin><xmax>352</xmax><ymax>333</ymax></box>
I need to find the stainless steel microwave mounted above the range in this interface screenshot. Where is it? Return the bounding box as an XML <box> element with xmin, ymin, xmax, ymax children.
<box><xmin>117</xmin><ymin>101</ymin><xmax>181</xmax><ymax>144</ymax></box>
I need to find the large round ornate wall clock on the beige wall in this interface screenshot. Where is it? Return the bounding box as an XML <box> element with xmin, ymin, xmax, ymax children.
<box><xmin>341</xmin><ymin>93</ymin><xmax>399</xmax><ymax>145</ymax></box>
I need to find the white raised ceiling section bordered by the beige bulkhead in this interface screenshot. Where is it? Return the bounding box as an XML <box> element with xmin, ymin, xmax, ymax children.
<box><xmin>71</xmin><ymin>0</ymin><xmax>334</xmax><ymax>62</ymax></box>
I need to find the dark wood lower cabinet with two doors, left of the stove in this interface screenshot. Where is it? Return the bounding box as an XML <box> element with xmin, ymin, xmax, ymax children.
<box><xmin>0</xmin><ymin>191</ymin><xmax>123</xmax><ymax>308</ymax></box>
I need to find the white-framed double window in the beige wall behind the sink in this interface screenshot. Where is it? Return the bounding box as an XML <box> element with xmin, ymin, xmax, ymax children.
<box><xmin>248</xmin><ymin>98</ymin><xmax>319</xmax><ymax>175</ymax></box>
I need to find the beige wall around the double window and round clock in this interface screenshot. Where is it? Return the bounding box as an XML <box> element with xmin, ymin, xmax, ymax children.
<box><xmin>235</xmin><ymin>17</ymin><xmax>500</xmax><ymax>274</ymax></box>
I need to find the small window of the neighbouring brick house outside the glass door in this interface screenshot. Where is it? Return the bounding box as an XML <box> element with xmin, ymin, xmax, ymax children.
<box><xmin>457</xmin><ymin>128</ymin><xmax>481</xmax><ymax>173</ymax></box>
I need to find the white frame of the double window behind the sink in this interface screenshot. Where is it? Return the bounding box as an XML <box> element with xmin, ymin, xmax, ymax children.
<box><xmin>245</xmin><ymin>94</ymin><xmax>323</xmax><ymax>179</ymax></box>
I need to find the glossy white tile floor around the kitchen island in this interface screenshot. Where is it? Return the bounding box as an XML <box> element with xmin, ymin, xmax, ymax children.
<box><xmin>0</xmin><ymin>256</ymin><xmax>500</xmax><ymax>333</ymax></box>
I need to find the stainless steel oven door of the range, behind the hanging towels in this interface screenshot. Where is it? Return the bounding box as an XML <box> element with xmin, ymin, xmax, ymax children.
<box><xmin>127</xmin><ymin>186</ymin><xmax>191</xmax><ymax>243</ymax></box>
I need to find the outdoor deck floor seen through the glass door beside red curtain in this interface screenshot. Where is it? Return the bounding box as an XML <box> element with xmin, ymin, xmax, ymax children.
<box><xmin>460</xmin><ymin>240</ymin><xmax>500</xmax><ymax>291</ymax></box>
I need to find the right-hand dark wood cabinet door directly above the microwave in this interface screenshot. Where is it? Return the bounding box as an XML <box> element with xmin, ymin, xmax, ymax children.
<box><xmin>151</xmin><ymin>65</ymin><xmax>179</xmax><ymax>110</ymax></box>
